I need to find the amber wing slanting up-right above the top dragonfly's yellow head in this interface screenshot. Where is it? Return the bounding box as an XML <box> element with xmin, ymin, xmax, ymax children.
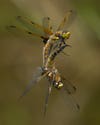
<box><xmin>57</xmin><ymin>10</ymin><xmax>76</xmax><ymax>31</ymax></box>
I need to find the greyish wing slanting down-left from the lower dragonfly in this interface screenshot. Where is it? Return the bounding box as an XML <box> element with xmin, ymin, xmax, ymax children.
<box><xmin>19</xmin><ymin>67</ymin><xmax>45</xmax><ymax>100</ymax></box>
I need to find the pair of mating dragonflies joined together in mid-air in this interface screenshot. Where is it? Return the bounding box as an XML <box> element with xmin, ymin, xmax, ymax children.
<box><xmin>9</xmin><ymin>11</ymin><xmax>79</xmax><ymax>114</ymax></box>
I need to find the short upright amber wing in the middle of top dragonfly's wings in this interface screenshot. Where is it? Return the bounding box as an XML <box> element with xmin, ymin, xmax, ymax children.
<box><xmin>43</xmin><ymin>17</ymin><xmax>53</xmax><ymax>38</ymax></box>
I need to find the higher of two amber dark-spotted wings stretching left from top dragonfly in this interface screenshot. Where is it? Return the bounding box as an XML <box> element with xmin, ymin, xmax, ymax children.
<box><xmin>17</xmin><ymin>16</ymin><xmax>52</xmax><ymax>35</ymax></box>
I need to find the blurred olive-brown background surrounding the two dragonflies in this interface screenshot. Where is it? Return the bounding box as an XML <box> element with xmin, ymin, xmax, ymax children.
<box><xmin>0</xmin><ymin>0</ymin><xmax>100</xmax><ymax>125</ymax></box>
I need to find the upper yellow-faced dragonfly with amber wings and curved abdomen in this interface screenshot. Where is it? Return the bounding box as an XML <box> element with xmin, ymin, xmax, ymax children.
<box><xmin>8</xmin><ymin>10</ymin><xmax>75</xmax><ymax>67</ymax></box>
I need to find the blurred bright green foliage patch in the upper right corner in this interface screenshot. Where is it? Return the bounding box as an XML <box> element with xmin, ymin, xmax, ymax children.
<box><xmin>73</xmin><ymin>0</ymin><xmax>100</xmax><ymax>45</ymax></box>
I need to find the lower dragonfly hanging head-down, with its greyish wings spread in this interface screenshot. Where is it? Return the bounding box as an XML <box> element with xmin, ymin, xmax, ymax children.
<box><xmin>19</xmin><ymin>65</ymin><xmax>80</xmax><ymax>116</ymax></box>
